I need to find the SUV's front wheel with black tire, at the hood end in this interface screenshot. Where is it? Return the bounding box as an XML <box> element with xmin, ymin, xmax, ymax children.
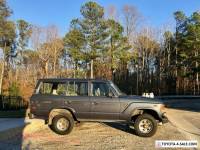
<box><xmin>134</xmin><ymin>114</ymin><xmax>158</xmax><ymax>137</ymax></box>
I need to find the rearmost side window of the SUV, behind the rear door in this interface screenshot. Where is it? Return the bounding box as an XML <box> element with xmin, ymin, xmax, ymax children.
<box><xmin>39</xmin><ymin>83</ymin><xmax>67</xmax><ymax>95</ymax></box>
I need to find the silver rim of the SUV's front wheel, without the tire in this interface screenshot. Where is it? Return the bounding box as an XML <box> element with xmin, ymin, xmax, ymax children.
<box><xmin>139</xmin><ymin>119</ymin><xmax>153</xmax><ymax>133</ymax></box>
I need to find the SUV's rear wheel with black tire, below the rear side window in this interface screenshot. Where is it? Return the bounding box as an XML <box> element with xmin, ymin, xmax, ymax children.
<box><xmin>50</xmin><ymin>114</ymin><xmax>74</xmax><ymax>135</ymax></box>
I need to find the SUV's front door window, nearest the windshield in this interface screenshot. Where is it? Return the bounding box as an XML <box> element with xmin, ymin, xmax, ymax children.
<box><xmin>92</xmin><ymin>82</ymin><xmax>110</xmax><ymax>96</ymax></box>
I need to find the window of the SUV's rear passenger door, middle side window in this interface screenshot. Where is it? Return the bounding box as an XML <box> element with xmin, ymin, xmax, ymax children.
<box><xmin>66</xmin><ymin>82</ymin><xmax>88</xmax><ymax>96</ymax></box>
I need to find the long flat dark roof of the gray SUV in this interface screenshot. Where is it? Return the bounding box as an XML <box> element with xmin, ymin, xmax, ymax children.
<box><xmin>38</xmin><ymin>78</ymin><xmax>109</xmax><ymax>82</ymax></box>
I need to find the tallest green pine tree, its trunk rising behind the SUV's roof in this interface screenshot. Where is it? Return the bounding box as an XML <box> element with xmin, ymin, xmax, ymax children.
<box><xmin>74</xmin><ymin>2</ymin><xmax>107</xmax><ymax>78</ymax></box>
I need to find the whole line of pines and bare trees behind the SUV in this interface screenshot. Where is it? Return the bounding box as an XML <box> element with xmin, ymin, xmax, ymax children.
<box><xmin>0</xmin><ymin>0</ymin><xmax>200</xmax><ymax>99</ymax></box>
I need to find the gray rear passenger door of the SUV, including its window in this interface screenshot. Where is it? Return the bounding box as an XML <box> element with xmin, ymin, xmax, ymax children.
<box><xmin>64</xmin><ymin>81</ymin><xmax>90</xmax><ymax>119</ymax></box>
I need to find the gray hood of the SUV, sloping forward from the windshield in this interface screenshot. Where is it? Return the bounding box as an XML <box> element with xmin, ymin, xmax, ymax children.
<box><xmin>120</xmin><ymin>95</ymin><xmax>163</xmax><ymax>104</ymax></box>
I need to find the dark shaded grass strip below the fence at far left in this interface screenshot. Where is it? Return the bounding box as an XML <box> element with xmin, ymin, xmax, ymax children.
<box><xmin>0</xmin><ymin>109</ymin><xmax>26</xmax><ymax>118</ymax></box>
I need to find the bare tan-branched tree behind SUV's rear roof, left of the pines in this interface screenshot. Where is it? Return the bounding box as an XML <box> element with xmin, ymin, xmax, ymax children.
<box><xmin>32</xmin><ymin>25</ymin><xmax>64</xmax><ymax>77</ymax></box>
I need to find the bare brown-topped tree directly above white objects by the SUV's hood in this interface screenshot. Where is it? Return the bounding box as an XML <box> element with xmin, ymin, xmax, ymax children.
<box><xmin>135</xmin><ymin>27</ymin><xmax>159</xmax><ymax>92</ymax></box>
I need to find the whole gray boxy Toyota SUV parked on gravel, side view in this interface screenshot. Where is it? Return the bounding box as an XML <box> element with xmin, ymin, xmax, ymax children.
<box><xmin>29</xmin><ymin>78</ymin><xmax>168</xmax><ymax>137</ymax></box>
